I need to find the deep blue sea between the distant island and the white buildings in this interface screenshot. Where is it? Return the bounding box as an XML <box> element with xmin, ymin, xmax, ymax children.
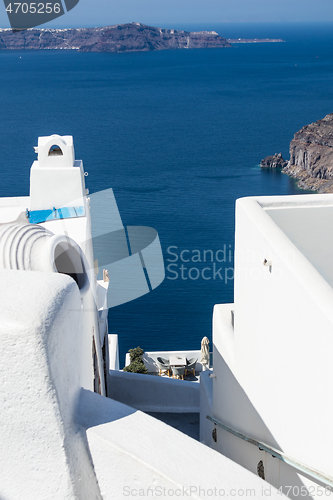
<box><xmin>0</xmin><ymin>23</ymin><xmax>333</xmax><ymax>364</ymax></box>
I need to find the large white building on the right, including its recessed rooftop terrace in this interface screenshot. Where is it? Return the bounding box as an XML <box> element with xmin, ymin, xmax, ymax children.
<box><xmin>201</xmin><ymin>195</ymin><xmax>333</xmax><ymax>498</ymax></box>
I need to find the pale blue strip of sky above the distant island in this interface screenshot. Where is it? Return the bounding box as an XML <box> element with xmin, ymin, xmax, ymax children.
<box><xmin>0</xmin><ymin>0</ymin><xmax>333</xmax><ymax>28</ymax></box>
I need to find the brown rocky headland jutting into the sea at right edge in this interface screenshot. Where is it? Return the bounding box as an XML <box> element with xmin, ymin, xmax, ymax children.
<box><xmin>261</xmin><ymin>113</ymin><xmax>333</xmax><ymax>193</ymax></box>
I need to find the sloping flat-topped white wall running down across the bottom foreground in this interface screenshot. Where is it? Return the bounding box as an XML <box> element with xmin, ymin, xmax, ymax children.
<box><xmin>79</xmin><ymin>390</ymin><xmax>285</xmax><ymax>500</ymax></box>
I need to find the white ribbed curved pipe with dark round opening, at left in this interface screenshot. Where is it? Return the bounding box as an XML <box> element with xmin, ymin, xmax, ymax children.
<box><xmin>0</xmin><ymin>223</ymin><xmax>89</xmax><ymax>296</ymax></box>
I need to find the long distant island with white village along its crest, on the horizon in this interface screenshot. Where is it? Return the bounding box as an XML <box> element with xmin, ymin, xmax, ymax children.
<box><xmin>0</xmin><ymin>23</ymin><xmax>231</xmax><ymax>52</ymax></box>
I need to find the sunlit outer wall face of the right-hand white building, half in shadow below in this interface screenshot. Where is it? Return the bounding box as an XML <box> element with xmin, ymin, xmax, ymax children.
<box><xmin>211</xmin><ymin>195</ymin><xmax>333</xmax><ymax>497</ymax></box>
